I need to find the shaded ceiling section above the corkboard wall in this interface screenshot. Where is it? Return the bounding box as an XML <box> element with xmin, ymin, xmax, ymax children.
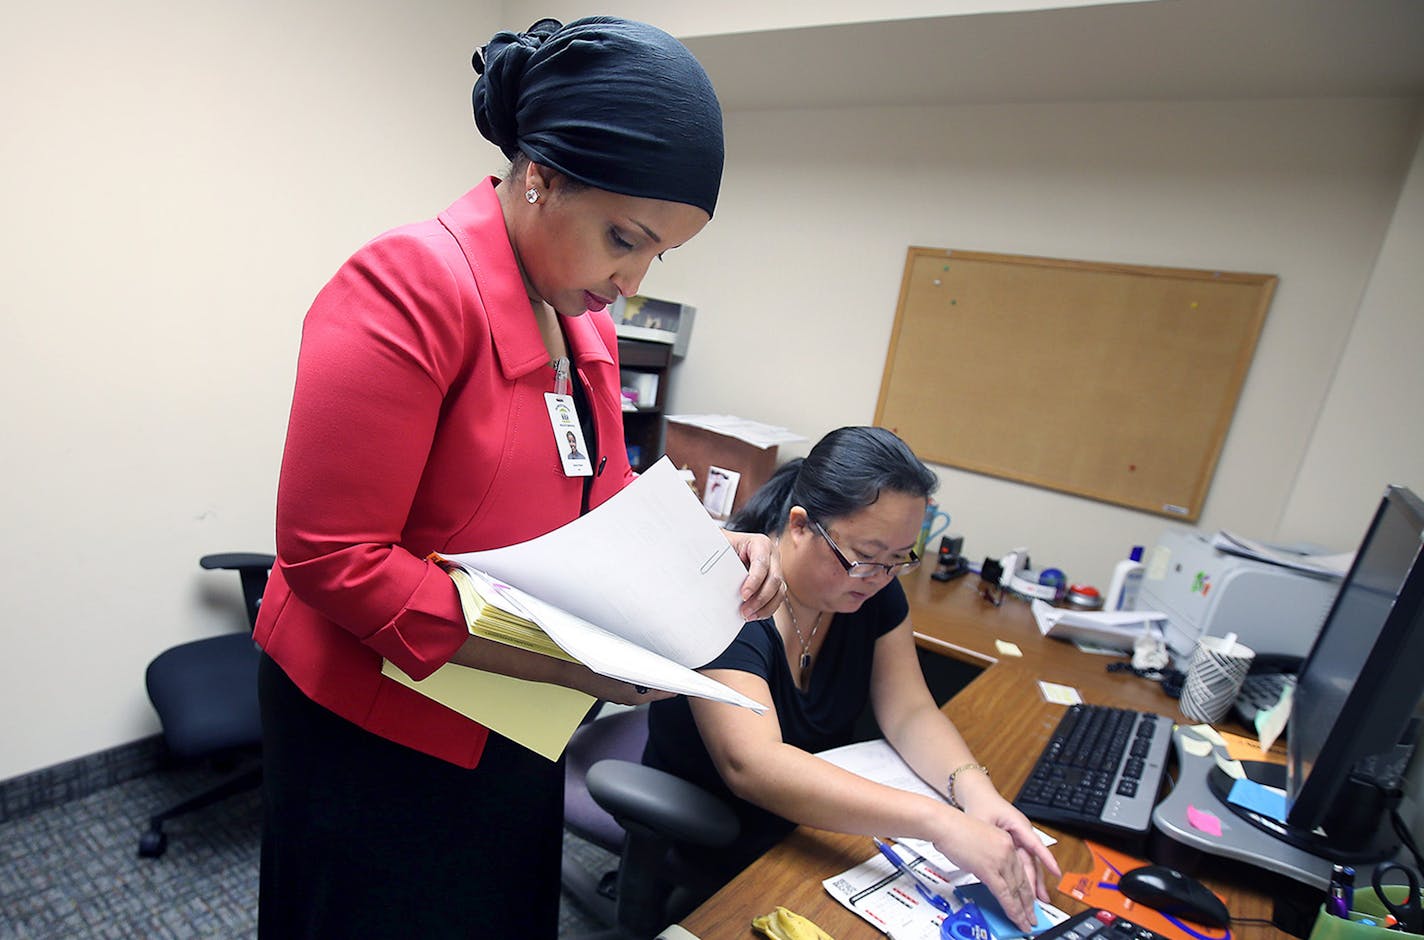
<box><xmin>685</xmin><ymin>0</ymin><xmax>1424</xmax><ymax>111</ymax></box>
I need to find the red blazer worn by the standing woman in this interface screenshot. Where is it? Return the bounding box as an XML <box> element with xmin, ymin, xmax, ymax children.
<box><xmin>256</xmin><ymin>178</ymin><xmax>632</xmax><ymax>766</ymax></box>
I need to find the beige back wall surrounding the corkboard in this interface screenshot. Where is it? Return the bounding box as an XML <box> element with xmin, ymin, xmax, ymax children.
<box><xmin>649</xmin><ymin>100</ymin><xmax>1424</xmax><ymax>585</ymax></box>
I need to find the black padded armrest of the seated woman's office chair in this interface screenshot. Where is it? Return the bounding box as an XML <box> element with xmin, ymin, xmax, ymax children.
<box><xmin>587</xmin><ymin>761</ymin><xmax>740</xmax><ymax>847</ymax></box>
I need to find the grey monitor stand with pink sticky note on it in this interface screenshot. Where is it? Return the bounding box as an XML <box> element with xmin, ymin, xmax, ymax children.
<box><xmin>1152</xmin><ymin>726</ymin><xmax>1388</xmax><ymax>892</ymax></box>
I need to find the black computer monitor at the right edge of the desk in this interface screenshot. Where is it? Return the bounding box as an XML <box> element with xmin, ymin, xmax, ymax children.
<box><xmin>1286</xmin><ymin>486</ymin><xmax>1424</xmax><ymax>850</ymax></box>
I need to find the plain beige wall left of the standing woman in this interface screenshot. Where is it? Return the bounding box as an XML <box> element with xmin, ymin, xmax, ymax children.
<box><xmin>0</xmin><ymin>0</ymin><xmax>501</xmax><ymax>779</ymax></box>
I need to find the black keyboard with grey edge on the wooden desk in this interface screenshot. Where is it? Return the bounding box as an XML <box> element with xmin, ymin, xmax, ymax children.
<box><xmin>1014</xmin><ymin>705</ymin><xmax>1172</xmax><ymax>836</ymax></box>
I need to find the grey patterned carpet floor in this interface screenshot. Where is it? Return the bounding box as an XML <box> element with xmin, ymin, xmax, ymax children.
<box><xmin>0</xmin><ymin>771</ymin><xmax>614</xmax><ymax>940</ymax></box>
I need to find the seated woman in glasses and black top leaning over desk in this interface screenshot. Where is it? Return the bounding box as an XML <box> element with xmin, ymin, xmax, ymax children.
<box><xmin>644</xmin><ymin>427</ymin><xmax>1061</xmax><ymax>929</ymax></box>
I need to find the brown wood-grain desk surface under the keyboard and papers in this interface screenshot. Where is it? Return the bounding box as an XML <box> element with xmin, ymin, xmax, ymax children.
<box><xmin>682</xmin><ymin>565</ymin><xmax>1279</xmax><ymax>940</ymax></box>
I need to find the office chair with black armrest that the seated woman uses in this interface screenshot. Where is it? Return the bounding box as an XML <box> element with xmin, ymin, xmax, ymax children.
<box><xmin>562</xmin><ymin>706</ymin><xmax>739</xmax><ymax>940</ymax></box>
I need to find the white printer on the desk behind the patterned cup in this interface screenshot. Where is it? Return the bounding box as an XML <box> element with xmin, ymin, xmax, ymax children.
<box><xmin>1136</xmin><ymin>531</ymin><xmax>1340</xmax><ymax>664</ymax></box>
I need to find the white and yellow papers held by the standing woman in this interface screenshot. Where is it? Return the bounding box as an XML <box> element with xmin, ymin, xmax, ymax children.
<box><xmin>383</xmin><ymin>457</ymin><xmax>766</xmax><ymax>759</ymax></box>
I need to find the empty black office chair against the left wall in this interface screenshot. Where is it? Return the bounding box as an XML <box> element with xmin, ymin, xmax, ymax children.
<box><xmin>138</xmin><ymin>553</ymin><xmax>276</xmax><ymax>859</ymax></box>
